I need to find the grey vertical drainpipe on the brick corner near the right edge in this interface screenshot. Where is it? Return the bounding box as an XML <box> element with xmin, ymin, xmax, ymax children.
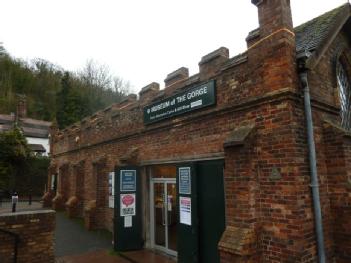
<box><xmin>299</xmin><ymin>69</ymin><xmax>326</xmax><ymax>263</ymax></box>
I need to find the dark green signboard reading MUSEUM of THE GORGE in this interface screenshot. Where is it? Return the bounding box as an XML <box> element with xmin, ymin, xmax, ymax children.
<box><xmin>144</xmin><ymin>80</ymin><xmax>216</xmax><ymax>124</ymax></box>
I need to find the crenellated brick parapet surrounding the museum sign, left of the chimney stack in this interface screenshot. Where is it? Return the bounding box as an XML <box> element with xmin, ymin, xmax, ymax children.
<box><xmin>53</xmin><ymin>30</ymin><xmax>296</xmax><ymax>155</ymax></box>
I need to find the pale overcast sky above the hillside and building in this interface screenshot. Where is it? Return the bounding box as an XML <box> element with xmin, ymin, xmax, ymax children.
<box><xmin>0</xmin><ymin>0</ymin><xmax>347</xmax><ymax>92</ymax></box>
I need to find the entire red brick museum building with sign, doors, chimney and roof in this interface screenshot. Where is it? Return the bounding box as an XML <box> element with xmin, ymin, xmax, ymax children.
<box><xmin>44</xmin><ymin>0</ymin><xmax>351</xmax><ymax>262</ymax></box>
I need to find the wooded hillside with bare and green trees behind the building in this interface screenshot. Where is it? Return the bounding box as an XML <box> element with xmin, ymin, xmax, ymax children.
<box><xmin>0</xmin><ymin>46</ymin><xmax>129</xmax><ymax>128</ymax></box>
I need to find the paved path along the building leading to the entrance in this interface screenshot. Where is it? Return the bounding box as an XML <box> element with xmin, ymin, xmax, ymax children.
<box><xmin>55</xmin><ymin>212</ymin><xmax>175</xmax><ymax>263</ymax></box>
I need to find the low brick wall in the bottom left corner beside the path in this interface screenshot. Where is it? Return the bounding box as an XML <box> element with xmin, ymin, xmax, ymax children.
<box><xmin>0</xmin><ymin>210</ymin><xmax>55</xmax><ymax>263</ymax></box>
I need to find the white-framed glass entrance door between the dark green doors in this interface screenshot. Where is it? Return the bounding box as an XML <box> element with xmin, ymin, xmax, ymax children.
<box><xmin>150</xmin><ymin>178</ymin><xmax>178</xmax><ymax>256</ymax></box>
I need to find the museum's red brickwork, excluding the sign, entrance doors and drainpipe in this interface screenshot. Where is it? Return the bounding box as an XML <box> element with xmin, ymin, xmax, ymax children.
<box><xmin>45</xmin><ymin>0</ymin><xmax>351</xmax><ymax>263</ymax></box>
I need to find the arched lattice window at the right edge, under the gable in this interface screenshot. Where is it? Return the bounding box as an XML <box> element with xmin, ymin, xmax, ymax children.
<box><xmin>336</xmin><ymin>59</ymin><xmax>351</xmax><ymax>130</ymax></box>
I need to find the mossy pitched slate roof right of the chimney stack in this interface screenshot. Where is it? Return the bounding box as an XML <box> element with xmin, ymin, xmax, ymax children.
<box><xmin>294</xmin><ymin>4</ymin><xmax>349</xmax><ymax>53</ymax></box>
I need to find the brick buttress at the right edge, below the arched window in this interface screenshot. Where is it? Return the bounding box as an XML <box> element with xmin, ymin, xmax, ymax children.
<box><xmin>324</xmin><ymin>124</ymin><xmax>351</xmax><ymax>262</ymax></box>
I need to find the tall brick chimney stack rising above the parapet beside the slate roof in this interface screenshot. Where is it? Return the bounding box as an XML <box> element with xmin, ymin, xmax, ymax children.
<box><xmin>246</xmin><ymin>0</ymin><xmax>297</xmax><ymax>92</ymax></box>
